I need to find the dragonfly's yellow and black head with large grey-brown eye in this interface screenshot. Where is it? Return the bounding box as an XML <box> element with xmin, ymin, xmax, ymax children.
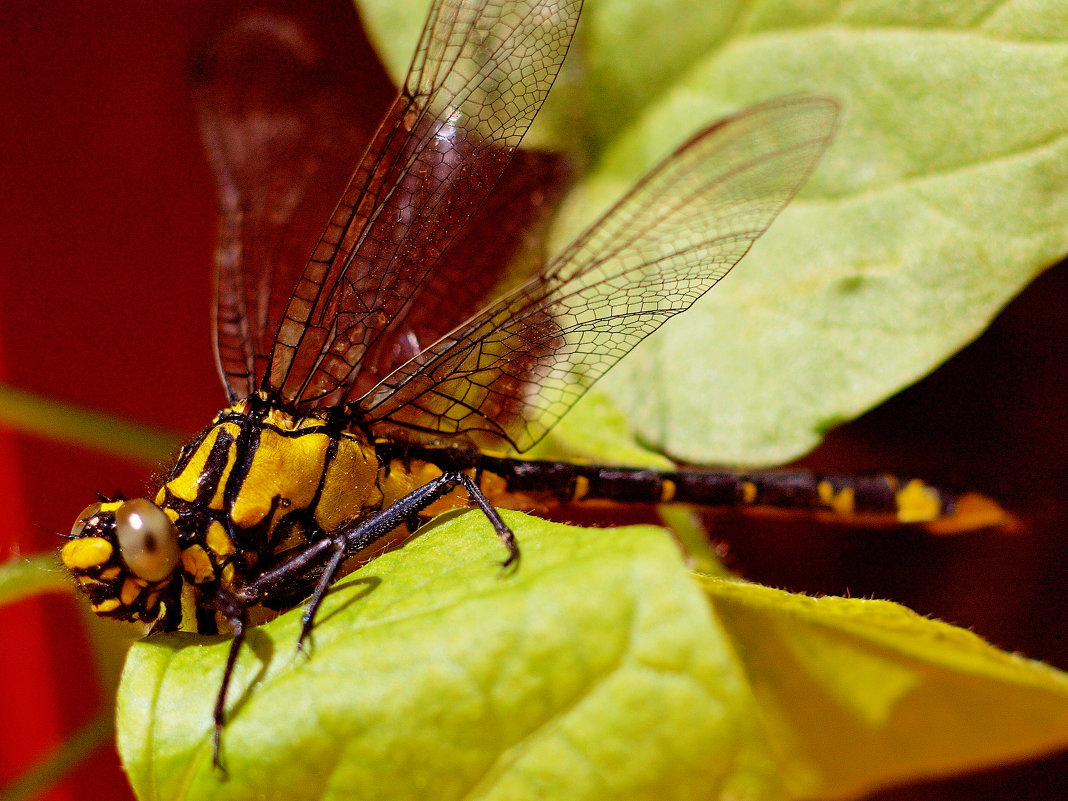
<box><xmin>60</xmin><ymin>498</ymin><xmax>182</xmax><ymax>623</ymax></box>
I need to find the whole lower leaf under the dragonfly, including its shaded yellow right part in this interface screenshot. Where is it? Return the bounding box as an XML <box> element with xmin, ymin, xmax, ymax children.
<box><xmin>117</xmin><ymin>513</ymin><xmax>1068</xmax><ymax>801</ymax></box>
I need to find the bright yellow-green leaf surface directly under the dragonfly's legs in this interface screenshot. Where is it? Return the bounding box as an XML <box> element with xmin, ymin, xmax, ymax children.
<box><xmin>117</xmin><ymin>513</ymin><xmax>778</xmax><ymax>801</ymax></box>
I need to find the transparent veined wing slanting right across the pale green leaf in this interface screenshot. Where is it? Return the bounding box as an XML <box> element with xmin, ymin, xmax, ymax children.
<box><xmin>352</xmin><ymin>98</ymin><xmax>837</xmax><ymax>451</ymax></box>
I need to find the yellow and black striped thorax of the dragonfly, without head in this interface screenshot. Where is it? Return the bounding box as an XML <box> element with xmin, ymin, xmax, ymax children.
<box><xmin>156</xmin><ymin>395</ymin><xmax>383</xmax><ymax>598</ymax></box>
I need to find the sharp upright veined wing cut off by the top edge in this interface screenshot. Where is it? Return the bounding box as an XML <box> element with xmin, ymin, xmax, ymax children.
<box><xmin>263</xmin><ymin>0</ymin><xmax>581</xmax><ymax>407</ymax></box>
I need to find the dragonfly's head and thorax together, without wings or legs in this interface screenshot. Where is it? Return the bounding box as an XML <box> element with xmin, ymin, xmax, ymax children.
<box><xmin>62</xmin><ymin>395</ymin><xmax>383</xmax><ymax>623</ymax></box>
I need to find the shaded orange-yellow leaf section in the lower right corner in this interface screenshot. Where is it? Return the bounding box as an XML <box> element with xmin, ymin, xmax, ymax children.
<box><xmin>702</xmin><ymin>578</ymin><xmax>1068</xmax><ymax>799</ymax></box>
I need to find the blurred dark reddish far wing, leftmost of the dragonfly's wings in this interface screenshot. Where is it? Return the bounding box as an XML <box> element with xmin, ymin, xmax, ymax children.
<box><xmin>192</xmin><ymin>12</ymin><xmax>391</xmax><ymax>399</ymax></box>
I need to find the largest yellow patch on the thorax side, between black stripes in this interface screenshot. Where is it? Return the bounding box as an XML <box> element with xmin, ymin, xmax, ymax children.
<box><xmin>231</xmin><ymin>429</ymin><xmax>330</xmax><ymax>529</ymax></box>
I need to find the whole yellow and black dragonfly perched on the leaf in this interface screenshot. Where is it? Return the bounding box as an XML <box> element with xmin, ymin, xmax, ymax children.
<box><xmin>61</xmin><ymin>0</ymin><xmax>974</xmax><ymax>766</ymax></box>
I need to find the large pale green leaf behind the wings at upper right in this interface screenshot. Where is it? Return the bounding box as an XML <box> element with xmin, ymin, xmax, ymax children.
<box><xmin>359</xmin><ymin>0</ymin><xmax>1068</xmax><ymax>464</ymax></box>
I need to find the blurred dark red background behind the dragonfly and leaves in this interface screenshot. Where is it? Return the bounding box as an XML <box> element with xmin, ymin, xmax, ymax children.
<box><xmin>0</xmin><ymin>0</ymin><xmax>1068</xmax><ymax>799</ymax></box>
